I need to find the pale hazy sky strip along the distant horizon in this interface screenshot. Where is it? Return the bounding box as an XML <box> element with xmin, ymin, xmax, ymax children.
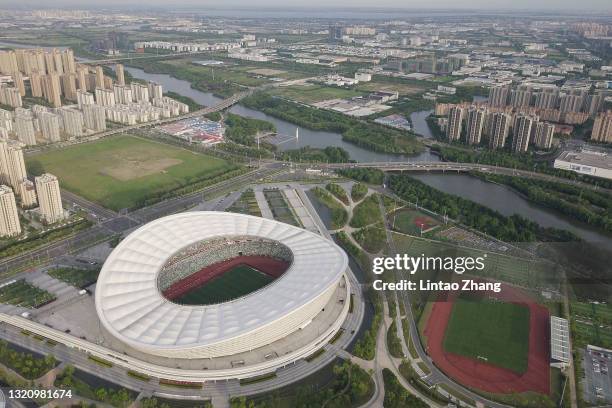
<box><xmin>0</xmin><ymin>0</ymin><xmax>612</xmax><ymax>13</ymax></box>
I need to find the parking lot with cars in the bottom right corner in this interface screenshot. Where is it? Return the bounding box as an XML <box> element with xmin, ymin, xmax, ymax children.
<box><xmin>582</xmin><ymin>349</ymin><xmax>612</xmax><ymax>405</ymax></box>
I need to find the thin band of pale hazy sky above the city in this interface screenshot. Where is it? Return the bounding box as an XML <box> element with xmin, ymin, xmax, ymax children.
<box><xmin>7</xmin><ymin>0</ymin><xmax>612</xmax><ymax>11</ymax></box>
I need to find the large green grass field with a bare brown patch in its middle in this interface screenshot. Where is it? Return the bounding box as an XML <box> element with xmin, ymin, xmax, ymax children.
<box><xmin>26</xmin><ymin>136</ymin><xmax>236</xmax><ymax>210</ymax></box>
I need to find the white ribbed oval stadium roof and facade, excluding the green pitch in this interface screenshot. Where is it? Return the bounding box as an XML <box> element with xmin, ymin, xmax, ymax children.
<box><xmin>95</xmin><ymin>211</ymin><xmax>348</xmax><ymax>359</ymax></box>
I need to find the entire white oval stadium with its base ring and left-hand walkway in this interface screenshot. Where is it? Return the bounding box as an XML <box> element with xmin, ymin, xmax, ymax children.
<box><xmin>3</xmin><ymin>211</ymin><xmax>350</xmax><ymax>382</ymax></box>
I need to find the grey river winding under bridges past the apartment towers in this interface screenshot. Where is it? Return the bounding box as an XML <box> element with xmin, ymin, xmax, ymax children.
<box><xmin>119</xmin><ymin>67</ymin><xmax>612</xmax><ymax>246</ymax></box>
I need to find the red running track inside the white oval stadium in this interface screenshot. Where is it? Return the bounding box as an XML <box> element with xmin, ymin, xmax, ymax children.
<box><xmin>162</xmin><ymin>255</ymin><xmax>289</xmax><ymax>300</ymax></box>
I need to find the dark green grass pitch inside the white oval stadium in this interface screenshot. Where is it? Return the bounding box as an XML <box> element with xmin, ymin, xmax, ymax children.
<box><xmin>173</xmin><ymin>265</ymin><xmax>274</xmax><ymax>305</ymax></box>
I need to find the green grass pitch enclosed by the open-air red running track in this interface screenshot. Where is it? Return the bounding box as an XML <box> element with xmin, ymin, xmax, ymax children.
<box><xmin>444</xmin><ymin>296</ymin><xmax>529</xmax><ymax>373</ymax></box>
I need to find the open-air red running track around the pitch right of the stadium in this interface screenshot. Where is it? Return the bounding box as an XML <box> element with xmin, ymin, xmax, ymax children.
<box><xmin>425</xmin><ymin>284</ymin><xmax>550</xmax><ymax>395</ymax></box>
